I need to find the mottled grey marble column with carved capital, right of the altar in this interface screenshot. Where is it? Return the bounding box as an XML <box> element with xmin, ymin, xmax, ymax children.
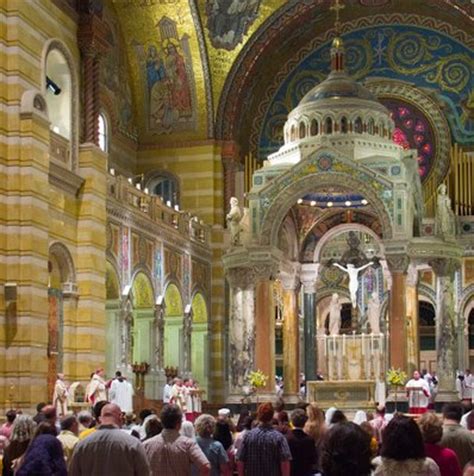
<box><xmin>429</xmin><ymin>258</ymin><xmax>459</xmax><ymax>402</ymax></box>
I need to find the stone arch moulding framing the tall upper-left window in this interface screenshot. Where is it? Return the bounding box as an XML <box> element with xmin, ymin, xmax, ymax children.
<box><xmin>41</xmin><ymin>38</ymin><xmax>80</xmax><ymax>171</ymax></box>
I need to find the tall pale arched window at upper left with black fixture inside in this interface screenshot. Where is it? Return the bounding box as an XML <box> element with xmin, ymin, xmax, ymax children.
<box><xmin>45</xmin><ymin>48</ymin><xmax>72</xmax><ymax>140</ymax></box>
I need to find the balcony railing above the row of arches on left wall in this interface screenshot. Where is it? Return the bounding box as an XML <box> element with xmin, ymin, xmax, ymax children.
<box><xmin>107</xmin><ymin>173</ymin><xmax>210</xmax><ymax>245</ymax></box>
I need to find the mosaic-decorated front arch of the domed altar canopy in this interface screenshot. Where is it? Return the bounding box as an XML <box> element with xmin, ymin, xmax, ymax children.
<box><xmin>259</xmin><ymin>172</ymin><xmax>392</xmax><ymax>247</ymax></box>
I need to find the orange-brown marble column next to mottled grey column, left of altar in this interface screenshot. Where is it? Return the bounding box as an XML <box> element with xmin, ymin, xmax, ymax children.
<box><xmin>255</xmin><ymin>277</ymin><xmax>275</xmax><ymax>393</ymax></box>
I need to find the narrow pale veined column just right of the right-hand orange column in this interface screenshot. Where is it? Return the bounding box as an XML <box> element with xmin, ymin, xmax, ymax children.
<box><xmin>406</xmin><ymin>265</ymin><xmax>420</xmax><ymax>375</ymax></box>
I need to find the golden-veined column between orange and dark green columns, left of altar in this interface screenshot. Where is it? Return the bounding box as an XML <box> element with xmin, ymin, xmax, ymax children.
<box><xmin>281</xmin><ymin>276</ymin><xmax>300</xmax><ymax>400</ymax></box>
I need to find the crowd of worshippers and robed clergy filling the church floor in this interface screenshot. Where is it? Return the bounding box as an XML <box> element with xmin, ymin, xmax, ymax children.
<box><xmin>0</xmin><ymin>369</ymin><xmax>474</xmax><ymax>476</ymax></box>
